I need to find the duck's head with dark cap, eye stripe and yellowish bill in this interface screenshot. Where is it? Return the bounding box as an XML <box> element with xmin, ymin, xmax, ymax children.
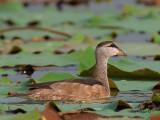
<box><xmin>96</xmin><ymin>41</ymin><xmax>127</xmax><ymax>59</ymax></box>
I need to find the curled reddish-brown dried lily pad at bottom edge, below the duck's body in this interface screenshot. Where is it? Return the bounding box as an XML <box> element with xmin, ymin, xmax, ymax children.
<box><xmin>41</xmin><ymin>102</ymin><xmax>142</xmax><ymax>120</ymax></box>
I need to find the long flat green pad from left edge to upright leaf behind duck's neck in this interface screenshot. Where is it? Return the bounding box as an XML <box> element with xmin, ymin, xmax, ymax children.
<box><xmin>0</xmin><ymin>50</ymin><xmax>82</xmax><ymax>66</ymax></box>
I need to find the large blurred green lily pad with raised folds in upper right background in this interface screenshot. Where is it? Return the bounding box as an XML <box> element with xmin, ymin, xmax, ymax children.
<box><xmin>88</xmin><ymin>5</ymin><xmax>160</xmax><ymax>33</ymax></box>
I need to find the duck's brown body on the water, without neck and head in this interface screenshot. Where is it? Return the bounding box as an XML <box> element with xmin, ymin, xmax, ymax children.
<box><xmin>27</xmin><ymin>79</ymin><xmax>109</xmax><ymax>100</ymax></box>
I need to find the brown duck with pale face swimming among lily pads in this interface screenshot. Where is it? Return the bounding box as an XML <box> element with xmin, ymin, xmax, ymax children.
<box><xmin>16</xmin><ymin>41</ymin><xmax>127</xmax><ymax>100</ymax></box>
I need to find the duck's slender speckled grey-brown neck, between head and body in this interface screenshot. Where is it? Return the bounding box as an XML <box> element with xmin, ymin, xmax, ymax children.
<box><xmin>92</xmin><ymin>58</ymin><xmax>110</xmax><ymax>94</ymax></box>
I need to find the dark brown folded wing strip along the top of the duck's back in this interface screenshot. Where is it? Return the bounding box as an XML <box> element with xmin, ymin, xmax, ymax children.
<box><xmin>26</xmin><ymin>79</ymin><xmax>102</xmax><ymax>89</ymax></box>
